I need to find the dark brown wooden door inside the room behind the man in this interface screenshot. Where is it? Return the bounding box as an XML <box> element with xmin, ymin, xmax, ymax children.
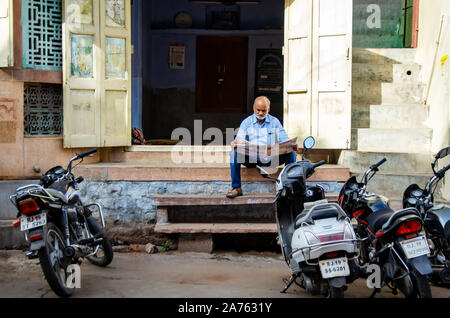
<box><xmin>196</xmin><ymin>36</ymin><xmax>248</xmax><ymax>112</ymax></box>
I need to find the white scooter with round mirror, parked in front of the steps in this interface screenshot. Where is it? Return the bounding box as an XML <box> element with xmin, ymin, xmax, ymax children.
<box><xmin>257</xmin><ymin>136</ymin><xmax>359</xmax><ymax>298</ymax></box>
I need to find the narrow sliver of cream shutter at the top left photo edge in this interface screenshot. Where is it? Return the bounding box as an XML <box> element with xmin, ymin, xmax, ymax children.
<box><xmin>0</xmin><ymin>0</ymin><xmax>14</xmax><ymax>67</ymax></box>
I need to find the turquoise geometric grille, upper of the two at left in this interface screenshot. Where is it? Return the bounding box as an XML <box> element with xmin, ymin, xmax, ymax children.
<box><xmin>22</xmin><ymin>0</ymin><xmax>62</xmax><ymax>71</ymax></box>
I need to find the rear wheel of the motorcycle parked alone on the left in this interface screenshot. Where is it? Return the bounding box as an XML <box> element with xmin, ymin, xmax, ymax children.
<box><xmin>39</xmin><ymin>222</ymin><xmax>74</xmax><ymax>297</ymax></box>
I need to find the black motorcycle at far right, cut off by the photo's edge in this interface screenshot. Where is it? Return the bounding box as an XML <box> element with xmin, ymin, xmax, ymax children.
<box><xmin>403</xmin><ymin>147</ymin><xmax>450</xmax><ymax>285</ymax></box>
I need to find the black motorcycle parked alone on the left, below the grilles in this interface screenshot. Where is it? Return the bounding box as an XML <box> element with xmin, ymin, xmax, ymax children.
<box><xmin>10</xmin><ymin>148</ymin><xmax>113</xmax><ymax>297</ymax></box>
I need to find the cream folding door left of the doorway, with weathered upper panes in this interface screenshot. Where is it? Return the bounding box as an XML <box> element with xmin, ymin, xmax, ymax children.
<box><xmin>63</xmin><ymin>0</ymin><xmax>131</xmax><ymax>148</ymax></box>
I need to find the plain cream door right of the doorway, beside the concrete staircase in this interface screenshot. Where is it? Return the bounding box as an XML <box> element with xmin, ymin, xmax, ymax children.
<box><xmin>284</xmin><ymin>0</ymin><xmax>353</xmax><ymax>149</ymax></box>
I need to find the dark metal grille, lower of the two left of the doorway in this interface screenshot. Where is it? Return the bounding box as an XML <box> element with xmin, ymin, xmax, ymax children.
<box><xmin>24</xmin><ymin>84</ymin><xmax>63</xmax><ymax>136</ymax></box>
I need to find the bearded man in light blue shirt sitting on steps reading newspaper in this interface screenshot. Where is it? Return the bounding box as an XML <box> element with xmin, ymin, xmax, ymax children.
<box><xmin>227</xmin><ymin>96</ymin><xmax>298</xmax><ymax>198</ymax></box>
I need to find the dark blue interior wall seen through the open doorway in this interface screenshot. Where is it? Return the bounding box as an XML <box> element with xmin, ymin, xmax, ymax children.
<box><xmin>142</xmin><ymin>0</ymin><xmax>284</xmax><ymax>139</ymax></box>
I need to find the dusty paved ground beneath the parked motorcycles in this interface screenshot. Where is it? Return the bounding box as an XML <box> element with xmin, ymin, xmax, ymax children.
<box><xmin>0</xmin><ymin>250</ymin><xmax>450</xmax><ymax>298</ymax></box>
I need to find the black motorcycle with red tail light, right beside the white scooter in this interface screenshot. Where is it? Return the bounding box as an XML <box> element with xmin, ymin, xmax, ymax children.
<box><xmin>338</xmin><ymin>158</ymin><xmax>432</xmax><ymax>298</ymax></box>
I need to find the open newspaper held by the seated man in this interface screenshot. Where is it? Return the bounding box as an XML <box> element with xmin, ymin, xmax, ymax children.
<box><xmin>236</xmin><ymin>137</ymin><xmax>297</xmax><ymax>159</ymax></box>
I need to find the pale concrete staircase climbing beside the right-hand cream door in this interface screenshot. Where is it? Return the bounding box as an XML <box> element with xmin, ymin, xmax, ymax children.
<box><xmin>344</xmin><ymin>49</ymin><xmax>433</xmax><ymax>202</ymax></box>
